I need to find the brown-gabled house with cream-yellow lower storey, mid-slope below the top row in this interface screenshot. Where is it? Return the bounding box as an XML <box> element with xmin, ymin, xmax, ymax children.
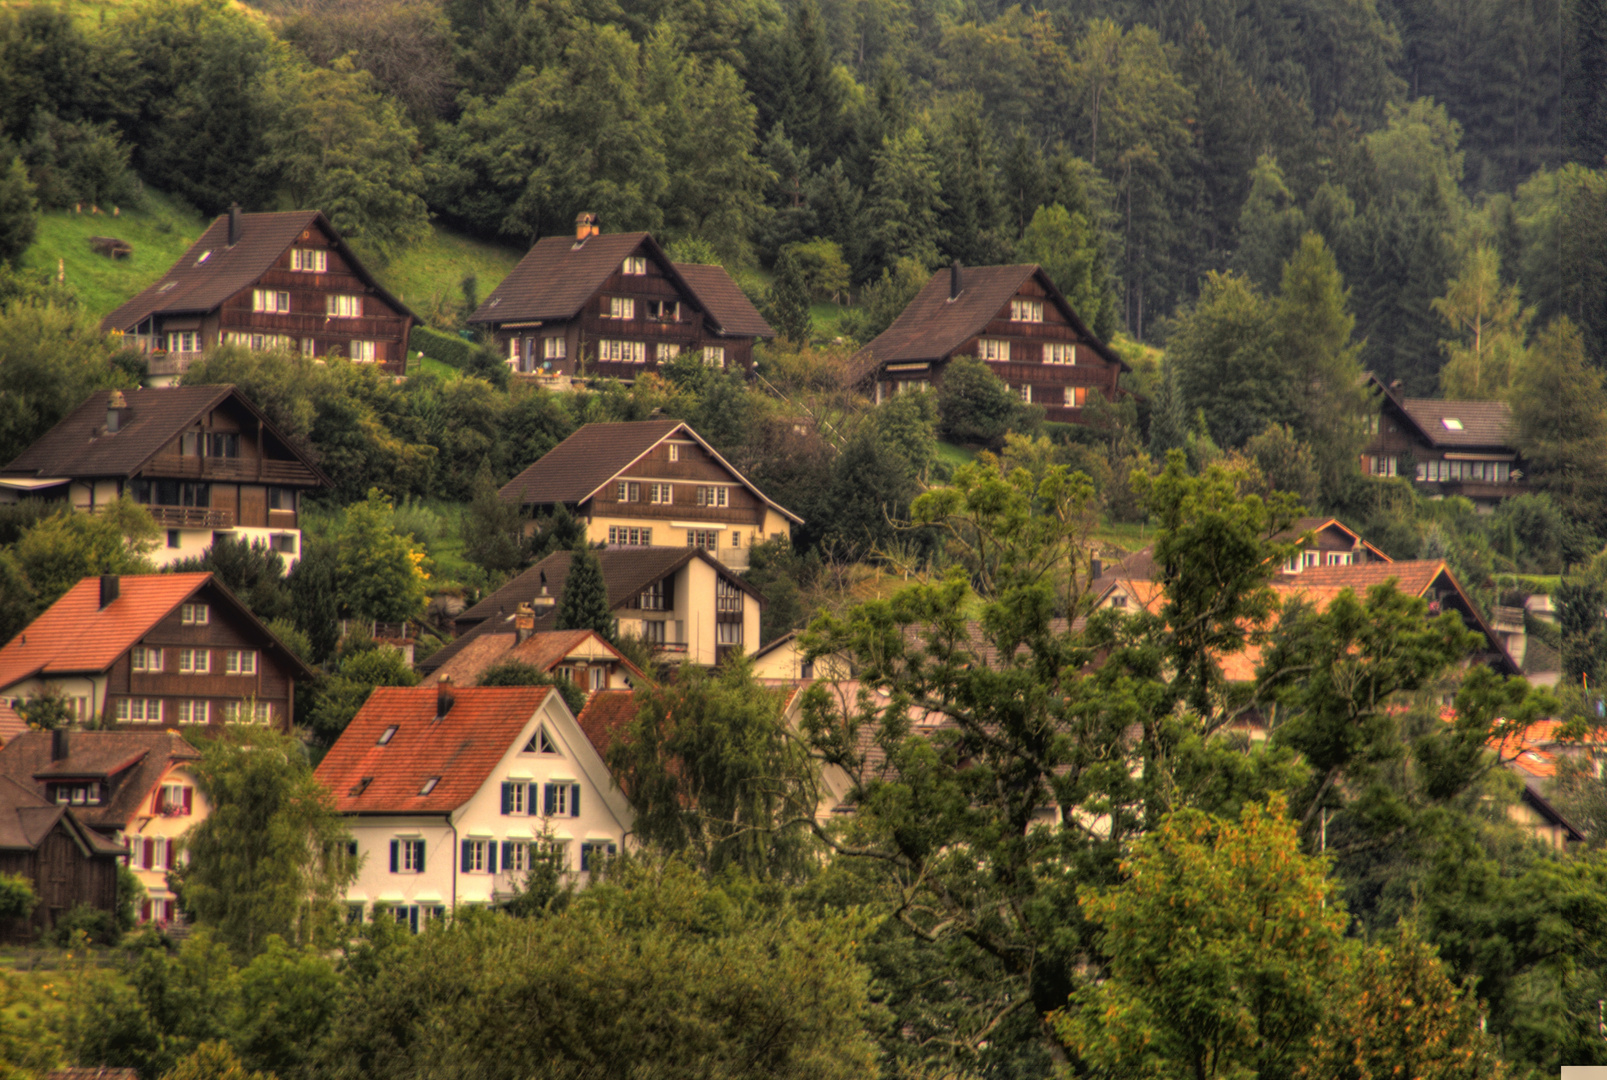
<box><xmin>500</xmin><ymin>419</ymin><xmax>804</xmax><ymax>571</ymax></box>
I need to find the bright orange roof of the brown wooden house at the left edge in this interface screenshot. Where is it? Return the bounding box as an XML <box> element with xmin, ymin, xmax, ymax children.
<box><xmin>0</xmin><ymin>572</ymin><xmax>312</xmax><ymax>689</ymax></box>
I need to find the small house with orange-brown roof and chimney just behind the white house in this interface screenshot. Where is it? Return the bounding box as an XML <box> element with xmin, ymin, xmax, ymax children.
<box><xmin>418</xmin><ymin>623</ymin><xmax>649</xmax><ymax>693</ymax></box>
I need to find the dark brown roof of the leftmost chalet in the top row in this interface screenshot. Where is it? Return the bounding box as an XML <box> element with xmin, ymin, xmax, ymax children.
<box><xmin>101</xmin><ymin>211</ymin><xmax>418</xmax><ymax>331</ymax></box>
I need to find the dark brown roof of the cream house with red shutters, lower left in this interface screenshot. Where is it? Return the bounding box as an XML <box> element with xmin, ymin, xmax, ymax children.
<box><xmin>0</xmin><ymin>731</ymin><xmax>201</xmax><ymax>831</ymax></box>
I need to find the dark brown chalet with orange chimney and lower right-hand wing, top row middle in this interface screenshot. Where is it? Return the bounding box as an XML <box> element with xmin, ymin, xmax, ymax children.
<box><xmin>469</xmin><ymin>214</ymin><xmax>776</xmax><ymax>381</ymax></box>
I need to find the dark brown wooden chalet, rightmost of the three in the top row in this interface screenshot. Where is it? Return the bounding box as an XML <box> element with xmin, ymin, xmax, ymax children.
<box><xmin>853</xmin><ymin>260</ymin><xmax>1130</xmax><ymax>423</ymax></box>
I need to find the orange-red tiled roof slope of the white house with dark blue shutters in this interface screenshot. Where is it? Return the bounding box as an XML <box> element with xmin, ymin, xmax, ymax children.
<box><xmin>315</xmin><ymin>686</ymin><xmax>553</xmax><ymax>813</ymax></box>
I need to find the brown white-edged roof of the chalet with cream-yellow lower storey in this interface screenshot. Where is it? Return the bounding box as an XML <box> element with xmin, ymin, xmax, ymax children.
<box><xmin>498</xmin><ymin>419</ymin><xmax>804</xmax><ymax>526</ymax></box>
